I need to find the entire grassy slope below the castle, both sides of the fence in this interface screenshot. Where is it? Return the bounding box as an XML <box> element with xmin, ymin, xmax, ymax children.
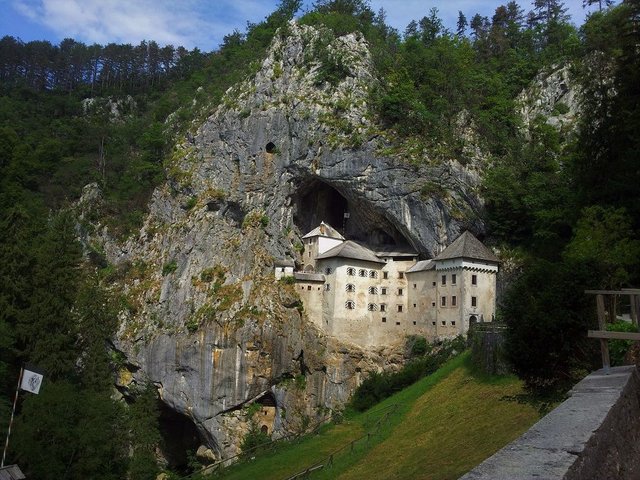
<box><xmin>206</xmin><ymin>354</ymin><xmax>539</xmax><ymax>480</ymax></box>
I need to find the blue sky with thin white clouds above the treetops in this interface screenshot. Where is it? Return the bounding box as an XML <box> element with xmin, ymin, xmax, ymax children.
<box><xmin>0</xmin><ymin>0</ymin><xmax>604</xmax><ymax>52</ymax></box>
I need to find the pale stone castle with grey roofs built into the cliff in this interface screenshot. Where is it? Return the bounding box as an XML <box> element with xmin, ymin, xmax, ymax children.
<box><xmin>275</xmin><ymin>222</ymin><xmax>499</xmax><ymax>347</ymax></box>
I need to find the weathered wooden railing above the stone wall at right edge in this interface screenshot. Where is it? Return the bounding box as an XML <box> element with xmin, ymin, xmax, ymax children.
<box><xmin>584</xmin><ymin>288</ymin><xmax>640</xmax><ymax>374</ymax></box>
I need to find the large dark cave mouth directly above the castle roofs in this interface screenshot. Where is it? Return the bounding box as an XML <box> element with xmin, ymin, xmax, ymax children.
<box><xmin>293</xmin><ymin>178</ymin><xmax>411</xmax><ymax>248</ymax></box>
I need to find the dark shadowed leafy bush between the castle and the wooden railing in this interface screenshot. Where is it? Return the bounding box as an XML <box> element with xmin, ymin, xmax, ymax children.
<box><xmin>502</xmin><ymin>258</ymin><xmax>598</xmax><ymax>392</ymax></box>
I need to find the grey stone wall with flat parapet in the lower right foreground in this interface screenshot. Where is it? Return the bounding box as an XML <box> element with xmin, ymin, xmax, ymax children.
<box><xmin>461</xmin><ymin>366</ymin><xmax>640</xmax><ymax>480</ymax></box>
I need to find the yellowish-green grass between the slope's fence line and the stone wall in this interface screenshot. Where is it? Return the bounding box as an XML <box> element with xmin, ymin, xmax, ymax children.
<box><xmin>335</xmin><ymin>355</ymin><xmax>539</xmax><ymax>480</ymax></box>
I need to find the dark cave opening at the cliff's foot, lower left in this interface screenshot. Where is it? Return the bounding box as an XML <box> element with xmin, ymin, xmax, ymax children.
<box><xmin>159</xmin><ymin>404</ymin><xmax>202</xmax><ymax>473</ymax></box>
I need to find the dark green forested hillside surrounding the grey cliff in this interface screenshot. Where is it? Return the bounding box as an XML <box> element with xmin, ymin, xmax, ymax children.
<box><xmin>0</xmin><ymin>0</ymin><xmax>640</xmax><ymax>479</ymax></box>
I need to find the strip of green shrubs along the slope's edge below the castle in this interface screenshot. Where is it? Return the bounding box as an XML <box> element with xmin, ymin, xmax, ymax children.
<box><xmin>349</xmin><ymin>337</ymin><xmax>465</xmax><ymax>412</ymax></box>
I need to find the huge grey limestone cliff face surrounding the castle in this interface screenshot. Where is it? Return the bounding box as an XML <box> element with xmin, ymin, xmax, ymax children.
<box><xmin>105</xmin><ymin>23</ymin><xmax>482</xmax><ymax>458</ymax></box>
